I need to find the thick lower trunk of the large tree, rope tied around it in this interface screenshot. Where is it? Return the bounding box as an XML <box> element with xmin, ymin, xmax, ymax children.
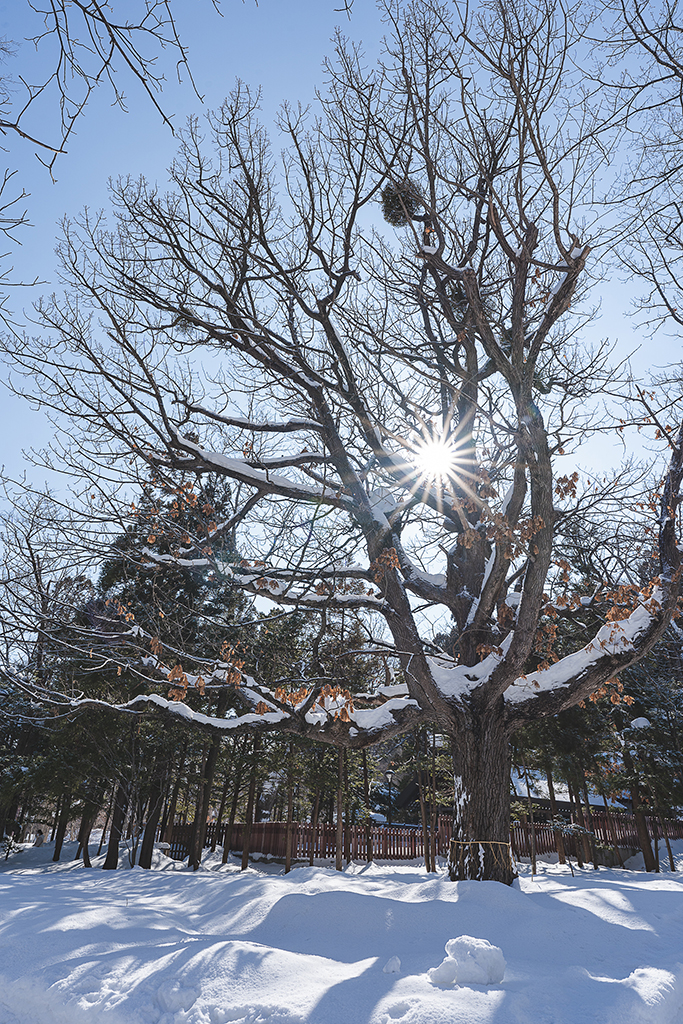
<box><xmin>449</xmin><ymin>701</ymin><xmax>514</xmax><ymax>885</ymax></box>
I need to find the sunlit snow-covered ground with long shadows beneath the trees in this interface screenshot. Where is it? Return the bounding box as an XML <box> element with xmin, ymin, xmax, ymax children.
<box><xmin>0</xmin><ymin>843</ymin><xmax>683</xmax><ymax>1024</ymax></box>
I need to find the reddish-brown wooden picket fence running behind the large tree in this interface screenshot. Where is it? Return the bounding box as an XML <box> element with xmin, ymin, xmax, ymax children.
<box><xmin>169</xmin><ymin>811</ymin><xmax>683</xmax><ymax>860</ymax></box>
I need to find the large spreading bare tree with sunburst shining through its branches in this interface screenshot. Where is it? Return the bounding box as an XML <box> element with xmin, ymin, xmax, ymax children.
<box><xmin>2</xmin><ymin>0</ymin><xmax>683</xmax><ymax>882</ymax></box>
